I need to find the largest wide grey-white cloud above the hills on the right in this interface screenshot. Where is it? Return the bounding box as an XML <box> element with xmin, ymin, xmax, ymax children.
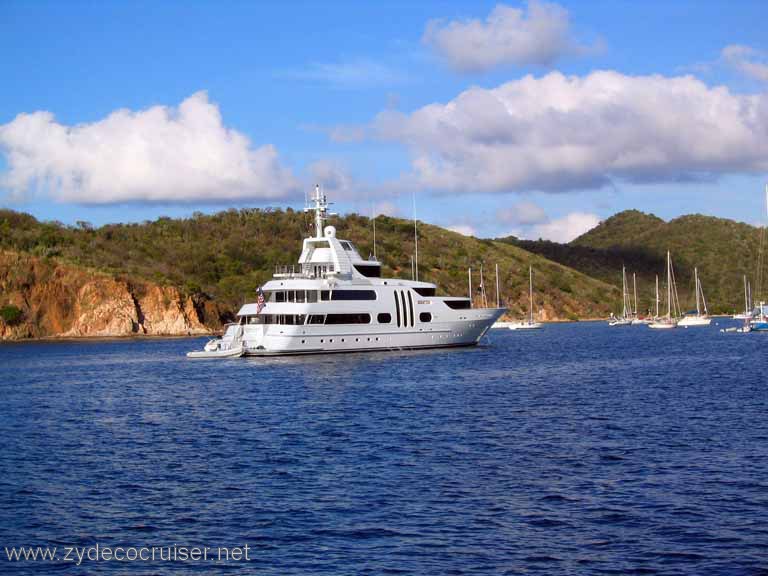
<box><xmin>372</xmin><ymin>71</ymin><xmax>768</xmax><ymax>193</ymax></box>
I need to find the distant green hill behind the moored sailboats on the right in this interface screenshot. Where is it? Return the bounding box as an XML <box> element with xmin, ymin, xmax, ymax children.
<box><xmin>504</xmin><ymin>210</ymin><xmax>764</xmax><ymax>313</ymax></box>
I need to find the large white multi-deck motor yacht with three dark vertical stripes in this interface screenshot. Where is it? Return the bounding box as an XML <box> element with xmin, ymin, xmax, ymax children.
<box><xmin>188</xmin><ymin>187</ymin><xmax>506</xmax><ymax>358</ymax></box>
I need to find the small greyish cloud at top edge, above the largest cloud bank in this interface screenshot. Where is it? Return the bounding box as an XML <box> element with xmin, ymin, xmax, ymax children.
<box><xmin>422</xmin><ymin>0</ymin><xmax>584</xmax><ymax>72</ymax></box>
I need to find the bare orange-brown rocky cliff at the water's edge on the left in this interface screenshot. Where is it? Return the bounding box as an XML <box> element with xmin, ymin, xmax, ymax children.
<box><xmin>0</xmin><ymin>252</ymin><xmax>225</xmax><ymax>340</ymax></box>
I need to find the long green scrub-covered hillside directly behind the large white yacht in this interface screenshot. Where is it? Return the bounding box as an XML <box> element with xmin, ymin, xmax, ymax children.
<box><xmin>0</xmin><ymin>209</ymin><xmax>620</xmax><ymax>326</ymax></box>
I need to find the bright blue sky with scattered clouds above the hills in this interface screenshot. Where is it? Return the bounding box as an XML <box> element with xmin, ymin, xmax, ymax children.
<box><xmin>0</xmin><ymin>0</ymin><xmax>768</xmax><ymax>241</ymax></box>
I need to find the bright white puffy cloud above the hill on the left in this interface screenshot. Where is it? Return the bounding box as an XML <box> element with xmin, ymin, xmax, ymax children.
<box><xmin>0</xmin><ymin>92</ymin><xmax>297</xmax><ymax>204</ymax></box>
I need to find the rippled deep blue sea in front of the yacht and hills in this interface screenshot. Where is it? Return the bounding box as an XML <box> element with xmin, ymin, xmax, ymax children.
<box><xmin>0</xmin><ymin>321</ymin><xmax>768</xmax><ymax>575</ymax></box>
